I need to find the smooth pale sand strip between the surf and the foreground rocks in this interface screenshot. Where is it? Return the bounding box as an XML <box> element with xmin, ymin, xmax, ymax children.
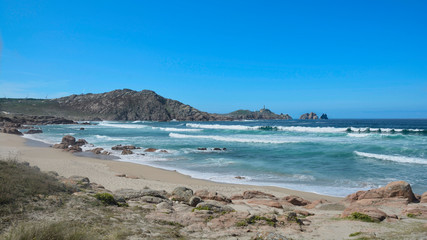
<box><xmin>0</xmin><ymin>133</ymin><xmax>343</xmax><ymax>202</ymax></box>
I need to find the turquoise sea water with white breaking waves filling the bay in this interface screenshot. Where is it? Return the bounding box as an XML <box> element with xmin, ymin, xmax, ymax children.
<box><xmin>22</xmin><ymin>120</ymin><xmax>427</xmax><ymax>196</ymax></box>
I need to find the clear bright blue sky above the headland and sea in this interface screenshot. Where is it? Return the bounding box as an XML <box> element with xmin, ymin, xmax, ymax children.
<box><xmin>0</xmin><ymin>0</ymin><xmax>427</xmax><ymax>118</ymax></box>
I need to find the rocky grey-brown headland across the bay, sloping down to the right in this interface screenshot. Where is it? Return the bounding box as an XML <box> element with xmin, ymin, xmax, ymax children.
<box><xmin>0</xmin><ymin>89</ymin><xmax>328</xmax><ymax>121</ymax></box>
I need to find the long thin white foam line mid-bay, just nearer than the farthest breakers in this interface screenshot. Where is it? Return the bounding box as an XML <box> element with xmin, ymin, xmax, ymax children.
<box><xmin>169</xmin><ymin>133</ymin><xmax>299</xmax><ymax>144</ymax></box>
